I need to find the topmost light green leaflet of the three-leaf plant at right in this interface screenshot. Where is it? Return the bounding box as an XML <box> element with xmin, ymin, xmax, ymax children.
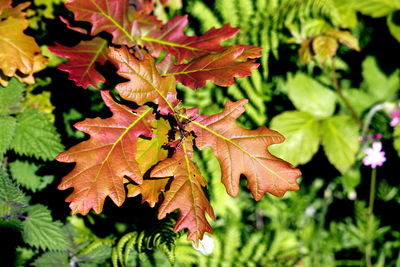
<box><xmin>286</xmin><ymin>72</ymin><xmax>336</xmax><ymax>118</ymax></box>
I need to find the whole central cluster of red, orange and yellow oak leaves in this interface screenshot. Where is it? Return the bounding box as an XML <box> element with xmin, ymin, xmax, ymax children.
<box><xmin>50</xmin><ymin>0</ymin><xmax>300</xmax><ymax>245</ymax></box>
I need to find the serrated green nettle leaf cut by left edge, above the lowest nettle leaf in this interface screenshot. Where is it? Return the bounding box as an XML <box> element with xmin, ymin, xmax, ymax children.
<box><xmin>0</xmin><ymin>168</ymin><xmax>28</xmax><ymax>219</ymax></box>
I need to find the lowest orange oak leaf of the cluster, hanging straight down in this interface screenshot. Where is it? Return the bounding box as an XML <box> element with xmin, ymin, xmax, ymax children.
<box><xmin>150</xmin><ymin>140</ymin><xmax>215</xmax><ymax>244</ymax></box>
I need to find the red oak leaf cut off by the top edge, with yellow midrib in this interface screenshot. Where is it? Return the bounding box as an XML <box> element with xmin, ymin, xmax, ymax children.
<box><xmin>65</xmin><ymin>0</ymin><xmax>161</xmax><ymax>45</ymax></box>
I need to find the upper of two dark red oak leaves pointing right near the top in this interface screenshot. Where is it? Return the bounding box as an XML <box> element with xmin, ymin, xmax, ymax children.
<box><xmin>141</xmin><ymin>16</ymin><xmax>239</xmax><ymax>63</ymax></box>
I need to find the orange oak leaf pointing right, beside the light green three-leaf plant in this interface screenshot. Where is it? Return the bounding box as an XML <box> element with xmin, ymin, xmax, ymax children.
<box><xmin>191</xmin><ymin>99</ymin><xmax>301</xmax><ymax>200</ymax></box>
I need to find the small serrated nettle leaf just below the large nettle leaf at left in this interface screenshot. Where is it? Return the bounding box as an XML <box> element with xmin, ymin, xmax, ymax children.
<box><xmin>10</xmin><ymin>160</ymin><xmax>54</xmax><ymax>192</ymax></box>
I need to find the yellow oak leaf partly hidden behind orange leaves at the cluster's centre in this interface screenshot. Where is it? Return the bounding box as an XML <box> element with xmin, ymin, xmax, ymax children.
<box><xmin>127</xmin><ymin>118</ymin><xmax>171</xmax><ymax>207</ymax></box>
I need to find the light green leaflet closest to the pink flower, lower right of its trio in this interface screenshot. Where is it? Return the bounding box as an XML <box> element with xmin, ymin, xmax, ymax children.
<box><xmin>321</xmin><ymin>115</ymin><xmax>360</xmax><ymax>174</ymax></box>
